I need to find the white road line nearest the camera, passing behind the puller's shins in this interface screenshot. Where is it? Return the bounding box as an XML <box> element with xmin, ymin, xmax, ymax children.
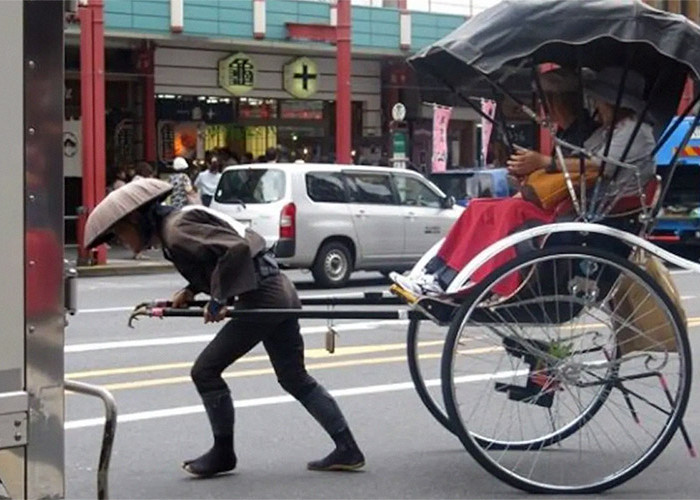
<box><xmin>65</xmin><ymin>370</ymin><xmax>528</xmax><ymax>430</ymax></box>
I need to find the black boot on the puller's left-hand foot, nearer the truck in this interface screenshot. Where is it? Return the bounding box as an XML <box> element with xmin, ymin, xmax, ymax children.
<box><xmin>182</xmin><ymin>391</ymin><xmax>237</xmax><ymax>477</ymax></box>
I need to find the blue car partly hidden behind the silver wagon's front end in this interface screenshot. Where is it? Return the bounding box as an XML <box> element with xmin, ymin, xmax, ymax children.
<box><xmin>430</xmin><ymin>168</ymin><xmax>513</xmax><ymax>206</ymax></box>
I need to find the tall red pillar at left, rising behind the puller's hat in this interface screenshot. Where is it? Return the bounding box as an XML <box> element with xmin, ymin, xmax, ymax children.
<box><xmin>78</xmin><ymin>0</ymin><xmax>107</xmax><ymax>264</ymax></box>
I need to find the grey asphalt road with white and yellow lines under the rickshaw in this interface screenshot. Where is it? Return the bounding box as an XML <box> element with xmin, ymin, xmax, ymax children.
<box><xmin>66</xmin><ymin>271</ymin><xmax>700</xmax><ymax>499</ymax></box>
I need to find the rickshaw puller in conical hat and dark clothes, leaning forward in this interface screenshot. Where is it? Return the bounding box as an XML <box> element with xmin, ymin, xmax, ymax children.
<box><xmin>85</xmin><ymin>179</ymin><xmax>365</xmax><ymax>477</ymax></box>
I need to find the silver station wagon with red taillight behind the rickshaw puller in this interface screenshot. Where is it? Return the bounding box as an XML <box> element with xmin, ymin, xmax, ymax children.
<box><xmin>211</xmin><ymin>163</ymin><xmax>462</xmax><ymax>287</ymax></box>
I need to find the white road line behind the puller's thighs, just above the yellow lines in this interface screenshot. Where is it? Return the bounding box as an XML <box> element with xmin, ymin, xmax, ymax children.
<box><xmin>64</xmin><ymin>319</ymin><xmax>408</xmax><ymax>354</ymax></box>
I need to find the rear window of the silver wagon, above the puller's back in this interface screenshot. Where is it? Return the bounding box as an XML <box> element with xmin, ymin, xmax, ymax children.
<box><xmin>216</xmin><ymin>168</ymin><xmax>286</xmax><ymax>203</ymax></box>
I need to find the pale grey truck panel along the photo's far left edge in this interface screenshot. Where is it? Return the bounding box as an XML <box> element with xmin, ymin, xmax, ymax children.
<box><xmin>0</xmin><ymin>2</ymin><xmax>27</xmax><ymax>498</ymax></box>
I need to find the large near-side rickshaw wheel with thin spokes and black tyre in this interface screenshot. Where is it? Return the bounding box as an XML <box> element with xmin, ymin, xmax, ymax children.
<box><xmin>442</xmin><ymin>246</ymin><xmax>692</xmax><ymax>493</ymax></box>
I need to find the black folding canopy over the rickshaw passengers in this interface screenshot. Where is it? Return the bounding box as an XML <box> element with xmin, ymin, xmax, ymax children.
<box><xmin>409</xmin><ymin>0</ymin><xmax>700</xmax><ymax>135</ymax></box>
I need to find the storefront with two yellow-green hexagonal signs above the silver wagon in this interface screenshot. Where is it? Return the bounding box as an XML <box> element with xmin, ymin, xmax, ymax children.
<box><xmin>155</xmin><ymin>46</ymin><xmax>382</xmax><ymax>163</ymax></box>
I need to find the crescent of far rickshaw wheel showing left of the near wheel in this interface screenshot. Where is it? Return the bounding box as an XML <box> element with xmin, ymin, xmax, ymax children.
<box><xmin>406</xmin><ymin>319</ymin><xmax>454</xmax><ymax>433</ymax></box>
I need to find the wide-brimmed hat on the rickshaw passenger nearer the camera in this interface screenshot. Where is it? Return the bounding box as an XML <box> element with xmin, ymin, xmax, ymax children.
<box><xmin>584</xmin><ymin>67</ymin><xmax>645</xmax><ymax>113</ymax></box>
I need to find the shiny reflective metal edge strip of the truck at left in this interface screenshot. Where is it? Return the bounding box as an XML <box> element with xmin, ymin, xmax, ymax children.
<box><xmin>23</xmin><ymin>0</ymin><xmax>65</xmax><ymax>498</ymax></box>
